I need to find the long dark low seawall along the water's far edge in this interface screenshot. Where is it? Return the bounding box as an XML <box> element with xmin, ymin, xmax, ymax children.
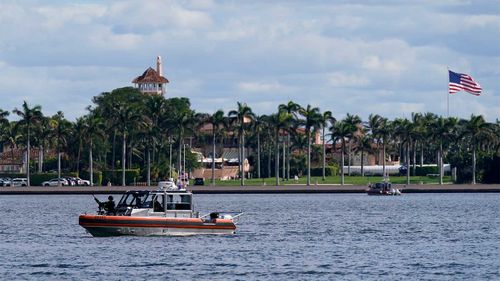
<box><xmin>0</xmin><ymin>184</ymin><xmax>500</xmax><ymax>195</ymax></box>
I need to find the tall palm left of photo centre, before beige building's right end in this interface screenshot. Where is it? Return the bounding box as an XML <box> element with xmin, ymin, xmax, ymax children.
<box><xmin>228</xmin><ymin>102</ymin><xmax>255</xmax><ymax>186</ymax></box>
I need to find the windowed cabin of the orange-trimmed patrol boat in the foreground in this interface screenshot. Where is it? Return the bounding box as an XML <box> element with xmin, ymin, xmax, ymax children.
<box><xmin>116</xmin><ymin>190</ymin><xmax>197</xmax><ymax>217</ymax></box>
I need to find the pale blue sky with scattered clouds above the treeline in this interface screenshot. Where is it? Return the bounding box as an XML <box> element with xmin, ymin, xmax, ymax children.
<box><xmin>0</xmin><ymin>0</ymin><xmax>500</xmax><ymax>121</ymax></box>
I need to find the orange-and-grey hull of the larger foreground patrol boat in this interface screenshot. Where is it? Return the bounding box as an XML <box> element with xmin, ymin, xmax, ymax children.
<box><xmin>79</xmin><ymin>215</ymin><xmax>236</xmax><ymax>237</ymax></box>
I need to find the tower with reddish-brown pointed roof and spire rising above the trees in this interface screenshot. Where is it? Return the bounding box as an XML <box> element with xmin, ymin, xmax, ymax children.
<box><xmin>132</xmin><ymin>56</ymin><xmax>169</xmax><ymax>95</ymax></box>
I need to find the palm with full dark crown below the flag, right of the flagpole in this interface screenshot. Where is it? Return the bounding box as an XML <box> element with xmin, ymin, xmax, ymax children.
<box><xmin>461</xmin><ymin>114</ymin><xmax>494</xmax><ymax>184</ymax></box>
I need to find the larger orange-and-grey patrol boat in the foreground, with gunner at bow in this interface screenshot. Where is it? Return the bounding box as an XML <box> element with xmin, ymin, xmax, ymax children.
<box><xmin>79</xmin><ymin>178</ymin><xmax>243</xmax><ymax>237</ymax></box>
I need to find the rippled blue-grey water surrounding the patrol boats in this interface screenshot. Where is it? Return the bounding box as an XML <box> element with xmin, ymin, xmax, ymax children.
<box><xmin>0</xmin><ymin>191</ymin><xmax>500</xmax><ymax>280</ymax></box>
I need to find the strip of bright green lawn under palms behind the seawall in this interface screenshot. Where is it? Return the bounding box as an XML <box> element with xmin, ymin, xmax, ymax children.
<box><xmin>191</xmin><ymin>176</ymin><xmax>451</xmax><ymax>186</ymax></box>
